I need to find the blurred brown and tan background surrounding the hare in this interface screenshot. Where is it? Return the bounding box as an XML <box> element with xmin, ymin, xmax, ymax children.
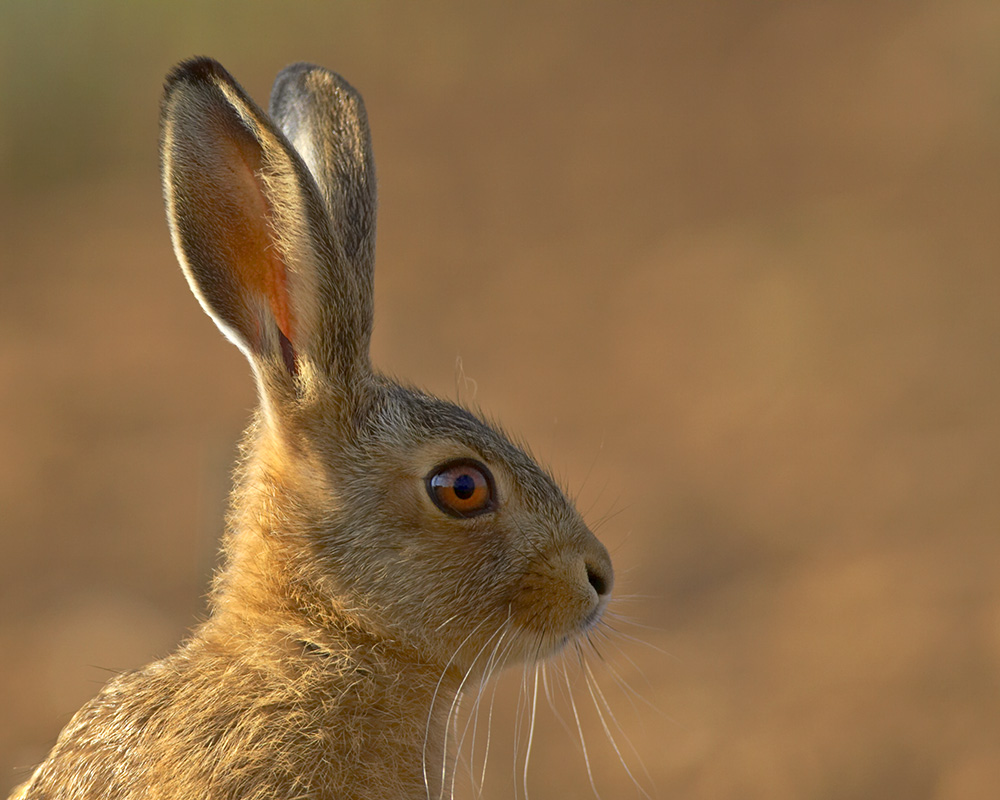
<box><xmin>0</xmin><ymin>0</ymin><xmax>1000</xmax><ymax>800</ymax></box>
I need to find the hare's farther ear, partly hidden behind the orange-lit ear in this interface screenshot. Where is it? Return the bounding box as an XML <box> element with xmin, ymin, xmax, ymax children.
<box><xmin>270</xmin><ymin>63</ymin><xmax>376</xmax><ymax>281</ymax></box>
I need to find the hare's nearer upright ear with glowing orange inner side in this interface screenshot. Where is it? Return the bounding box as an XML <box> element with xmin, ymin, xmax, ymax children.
<box><xmin>160</xmin><ymin>59</ymin><xmax>372</xmax><ymax>395</ymax></box>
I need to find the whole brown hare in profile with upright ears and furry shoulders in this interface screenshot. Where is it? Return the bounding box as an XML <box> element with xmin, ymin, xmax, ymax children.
<box><xmin>13</xmin><ymin>58</ymin><xmax>613</xmax><ymax>800</ymax></box>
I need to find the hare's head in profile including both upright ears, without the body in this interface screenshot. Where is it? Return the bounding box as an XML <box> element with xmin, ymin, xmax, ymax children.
<box><xmin>161</xmin><ymin>59</ymin><xmax>613</xmax><ymax>675</ymax></box>
